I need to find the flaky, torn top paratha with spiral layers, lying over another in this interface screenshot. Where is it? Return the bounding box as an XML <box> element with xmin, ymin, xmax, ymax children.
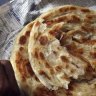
<box><xmin>28</xmin><ymin>5</ymin><xmax>96</xmax><ymax>90</ymax></box>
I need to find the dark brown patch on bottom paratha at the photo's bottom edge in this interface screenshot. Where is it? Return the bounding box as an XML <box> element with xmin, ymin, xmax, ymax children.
<box><xmin>33</xmin><ymin>86</ymin><xmax>57</xmax><ymax>96</ymax></box>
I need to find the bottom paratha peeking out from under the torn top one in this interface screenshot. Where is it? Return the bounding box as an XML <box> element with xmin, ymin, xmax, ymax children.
<box><xmin>10</xmin><ymin>22</ymin><xmax>96</xmax><ymax>96</ymax></box>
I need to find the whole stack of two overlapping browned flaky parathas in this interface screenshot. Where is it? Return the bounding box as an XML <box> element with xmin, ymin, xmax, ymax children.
<box><xmin>10</xmin><ymin>5</ymin><xmax>96</xmax><ymax>96</ymax></box>
